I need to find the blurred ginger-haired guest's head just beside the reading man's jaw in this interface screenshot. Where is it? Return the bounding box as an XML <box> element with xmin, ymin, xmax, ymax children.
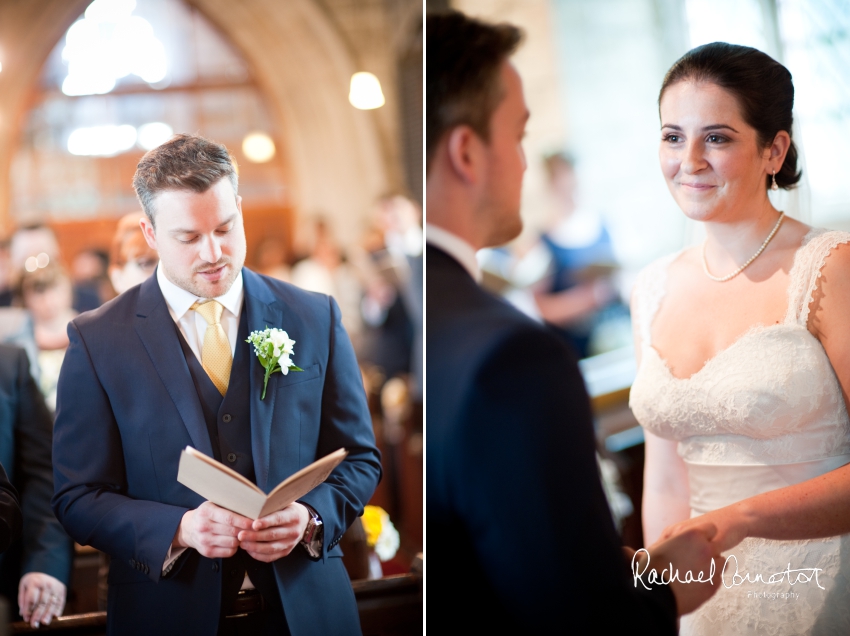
<box><xmin>109</xmin><ymin>212</ymin><xmax>159</xmax><ymax>294</ymax></box>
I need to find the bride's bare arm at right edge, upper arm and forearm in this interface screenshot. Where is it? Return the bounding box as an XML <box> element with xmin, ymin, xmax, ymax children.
<box><xmin>663</xmin><ymin>244</ymin><xmax>850</xmax><ymax>550</ymax></box>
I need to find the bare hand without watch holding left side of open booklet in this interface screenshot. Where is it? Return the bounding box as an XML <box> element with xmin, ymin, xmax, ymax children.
<box><xmin>171</xmin><ymin>501</ymin><xmax>251</xmax><ymax>559</ymax></box>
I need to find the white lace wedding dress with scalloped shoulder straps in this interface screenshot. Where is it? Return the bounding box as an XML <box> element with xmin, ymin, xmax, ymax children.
<box><xmin>630</xmin><ymin>229</ymin><xmax>850</xmax><ymax>636</ymax></box>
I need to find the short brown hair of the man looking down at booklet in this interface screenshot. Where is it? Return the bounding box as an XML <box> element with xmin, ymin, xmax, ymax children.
<box><xmin>133</xmin><ymin>134</ymin><xmax>239</xmax><ymax>226</ymax></box>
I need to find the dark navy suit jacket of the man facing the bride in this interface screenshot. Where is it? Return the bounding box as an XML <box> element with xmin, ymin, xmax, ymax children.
<box><xmin>426</xmin><ymin>245</ymin><xmax>676</xmax><ymax>635</ymax></box>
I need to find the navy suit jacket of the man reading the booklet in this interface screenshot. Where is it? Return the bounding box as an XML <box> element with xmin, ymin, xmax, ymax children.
<box><xmin>53</xmin><ymin>269</ymin><xmax>381</xmax><ymax>636</ymax></box>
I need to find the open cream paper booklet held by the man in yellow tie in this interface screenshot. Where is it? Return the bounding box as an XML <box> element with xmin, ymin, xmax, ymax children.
<box><xmin>177</xmin><ymin>446</ymin><xmax>348</xmax><ymax>519</ymax></box>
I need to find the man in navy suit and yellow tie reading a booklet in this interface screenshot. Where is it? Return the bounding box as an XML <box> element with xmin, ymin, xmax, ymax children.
<box><xmin>53</xmin><ymin>135</ymin><xmax>381</xmax><ymax>636</ymax></box>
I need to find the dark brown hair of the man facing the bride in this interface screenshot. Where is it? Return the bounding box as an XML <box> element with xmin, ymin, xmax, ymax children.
<box><xmin>425</xmin><ymin>11</ymin><xmax>522</xmax><ymax>169</ymax></box>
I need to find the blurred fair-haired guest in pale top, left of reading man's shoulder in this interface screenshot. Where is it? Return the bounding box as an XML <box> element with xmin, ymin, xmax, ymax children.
<box><xmin>17</xmin><ymin>263</ymin><xmax>77</xmax><ymax>411</ymax></box>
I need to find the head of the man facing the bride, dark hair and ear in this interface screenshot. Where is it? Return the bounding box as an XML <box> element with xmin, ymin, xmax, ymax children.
<box><xmin>425</xmin><ymin>11</ymin><xmax>528</xmax><ymax>249</ymax></box>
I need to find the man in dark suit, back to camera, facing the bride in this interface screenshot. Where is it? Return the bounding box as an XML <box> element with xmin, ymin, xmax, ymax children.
<box><xmin>426</xmin><ymin>12</ymin><xmax>718</xmax><ymax>634</ymax></box>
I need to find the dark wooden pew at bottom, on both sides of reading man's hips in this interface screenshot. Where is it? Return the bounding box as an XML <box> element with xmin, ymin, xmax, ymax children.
<box><xmin>11</xmin><ymin>561</ymin><xmax>423</xmax><ymax>636</ymax></box>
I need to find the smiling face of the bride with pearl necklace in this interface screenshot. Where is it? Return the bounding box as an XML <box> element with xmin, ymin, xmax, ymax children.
<box><xmin>658</xmin><ymin>81</ymin><xmax>770</xmax><ymax>222</ymax></box>
